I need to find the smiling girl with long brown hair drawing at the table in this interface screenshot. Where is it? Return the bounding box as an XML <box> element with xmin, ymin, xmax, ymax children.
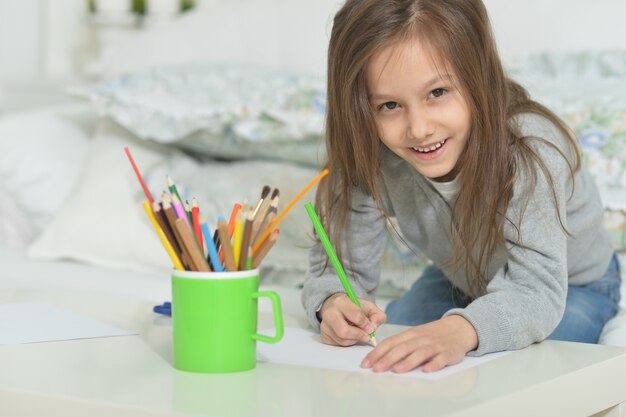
<box><xmin>302</xmin><ymin>0</ymin><xmax>620</xmax><ymax>372</ymax></box>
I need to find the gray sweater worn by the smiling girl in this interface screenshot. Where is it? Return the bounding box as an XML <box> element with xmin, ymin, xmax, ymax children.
<box><xmin>302</xmin><ymin>114</ymin><xmax>613</xmax><ymax>355</ymax></box>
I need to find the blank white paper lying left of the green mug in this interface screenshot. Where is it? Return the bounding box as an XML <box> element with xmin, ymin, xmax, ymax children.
<box><xmin>0</xmin><ymin>303</ymin><xmax>133</xmax><ymax>345</ymax></box>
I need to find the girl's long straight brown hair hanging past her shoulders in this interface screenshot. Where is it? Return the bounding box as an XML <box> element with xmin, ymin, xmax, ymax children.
<box><xmin>316</xmin><ymin>0</ymin><xmax>580</xmax><ymax>296</ymax></box>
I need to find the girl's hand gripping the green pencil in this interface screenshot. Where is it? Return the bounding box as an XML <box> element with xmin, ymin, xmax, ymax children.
<box><xmin>319</xmin><ymin>293</ymin><xmax>387</xmax><ymax>346</ymax></box>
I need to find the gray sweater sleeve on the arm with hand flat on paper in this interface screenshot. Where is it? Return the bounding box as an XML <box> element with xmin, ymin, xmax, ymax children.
<box><xmin>446</xmin><ymin>131</ymin><xmax>572</xmax><ymax>356</ymax></box>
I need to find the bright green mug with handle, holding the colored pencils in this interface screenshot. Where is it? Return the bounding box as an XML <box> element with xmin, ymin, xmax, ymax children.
<box><xmin>172</xmin><ymin>269</ymin><xmax>284</xmax><ymax>373</ymax></box>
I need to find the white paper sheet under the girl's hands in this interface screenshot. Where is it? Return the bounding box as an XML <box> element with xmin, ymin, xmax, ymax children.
<box><xmin>257</xmin><ymin>327</ymin><xmax>511</xmax><ymax>379</ymax></box>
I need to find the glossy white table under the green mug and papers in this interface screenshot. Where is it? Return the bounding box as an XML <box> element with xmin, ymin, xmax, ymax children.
<box><xmin>0</xmin><ymin>291</ymin><xmax>626</xmax><ymax>417</ymax></box>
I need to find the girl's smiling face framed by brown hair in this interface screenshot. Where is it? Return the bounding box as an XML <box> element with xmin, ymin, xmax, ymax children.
<box><xmin>366</xmin><ymin>38</ymin><xmax>470</xmax><ymax>181</ymax></box>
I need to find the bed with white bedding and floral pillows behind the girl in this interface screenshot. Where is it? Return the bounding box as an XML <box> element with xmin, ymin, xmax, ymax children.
<box><xmin>0</xmin><ymin>0</ymin><xmax>626</xmax><ymax>360</ymax></box>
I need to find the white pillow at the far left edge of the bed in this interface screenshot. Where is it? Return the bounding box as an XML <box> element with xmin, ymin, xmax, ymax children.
<box><xmin>0</xmin><ymin>103</ymin><xmax>96</xmax><ymax>248</ymax></box>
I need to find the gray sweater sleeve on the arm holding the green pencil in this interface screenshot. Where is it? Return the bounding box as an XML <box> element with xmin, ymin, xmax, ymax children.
<box><xmin>302</xmin><ymin>189</ymin><xmax>386</xmax><ymax>331</ymax></box>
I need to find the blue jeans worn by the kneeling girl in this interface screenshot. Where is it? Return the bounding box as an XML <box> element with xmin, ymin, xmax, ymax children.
<box><xmin>386</xmin><ymin>255</ymin><xmax>621</xmax><ymax>343</ymax></box>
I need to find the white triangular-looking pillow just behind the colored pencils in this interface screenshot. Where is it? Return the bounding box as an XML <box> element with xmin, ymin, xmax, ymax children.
<box><xmin>28</xmin><ymin>119</ymin><xmax>174</xmax><ymax>271</ymax></box>
